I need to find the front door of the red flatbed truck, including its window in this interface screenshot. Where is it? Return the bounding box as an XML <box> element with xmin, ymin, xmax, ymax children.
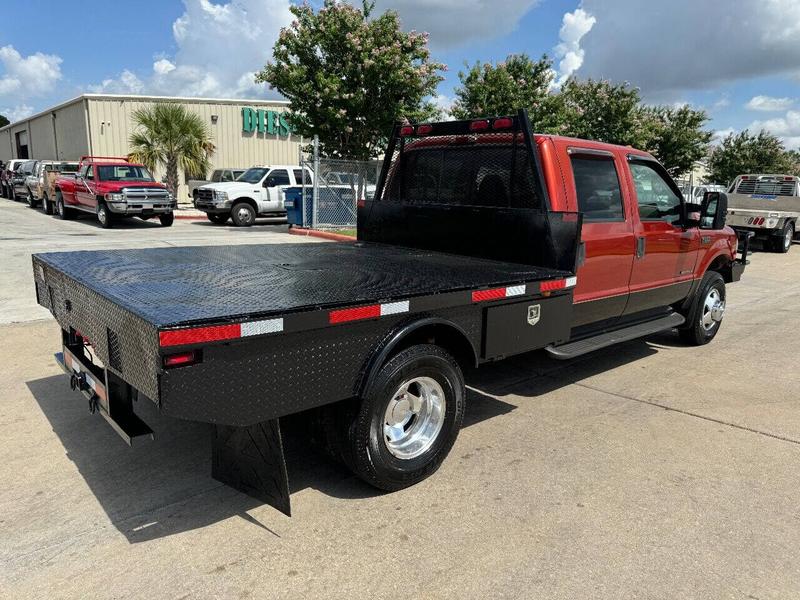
<box><xmin>625</xmin><ymin>155</ymin><xmax>700</xmax><ymax>314</ymax></box>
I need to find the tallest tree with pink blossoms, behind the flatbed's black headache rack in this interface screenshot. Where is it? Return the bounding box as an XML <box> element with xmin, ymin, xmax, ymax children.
<box><xmin>256</xmin><ymin>0</ymin><xmax>444</xmax><ymax>160</ymax></box>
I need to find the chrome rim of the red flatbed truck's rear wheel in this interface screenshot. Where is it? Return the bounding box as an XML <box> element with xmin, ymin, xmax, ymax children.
<box><xmin>383</xmin><ymin>377</ymin><xmax>445</xmax><ymax>460</ymax></box>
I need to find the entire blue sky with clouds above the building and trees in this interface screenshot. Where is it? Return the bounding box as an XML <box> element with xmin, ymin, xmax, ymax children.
<box><xmin>0</xmin><ymin>0</ymin><xmax>800</xmax><ymax>147</ymax></box>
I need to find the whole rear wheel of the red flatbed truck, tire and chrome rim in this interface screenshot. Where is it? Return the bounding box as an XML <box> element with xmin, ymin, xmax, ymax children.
<box><xmin>341</xmin><ymin>344</ymin><xmax>466</xmax><ymax>491</ymax></box>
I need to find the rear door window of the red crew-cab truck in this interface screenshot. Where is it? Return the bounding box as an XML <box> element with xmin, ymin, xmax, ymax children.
<box><xmin>570</xmin><ymin>154</ymin><xmax>625</xmax><ymax>223</ymax></box>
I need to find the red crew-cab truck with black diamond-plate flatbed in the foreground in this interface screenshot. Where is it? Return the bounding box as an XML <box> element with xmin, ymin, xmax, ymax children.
<box><xmin>33</xmin><ymin>111</ymin><xmax>746</xmax><ymax>514</ymax></box>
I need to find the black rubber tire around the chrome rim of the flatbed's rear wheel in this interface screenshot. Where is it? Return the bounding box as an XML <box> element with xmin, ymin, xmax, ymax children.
<box><xmin>338</xmin><ymin>344</ymin><xmax>466</xmax><ymax>491</ymax></box>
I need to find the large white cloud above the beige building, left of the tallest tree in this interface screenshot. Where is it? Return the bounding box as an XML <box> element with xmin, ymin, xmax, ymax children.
<box><xmin>89</xmin><ymin>0</ymin><xmax>293</xmax><ymax>97</ymax></box>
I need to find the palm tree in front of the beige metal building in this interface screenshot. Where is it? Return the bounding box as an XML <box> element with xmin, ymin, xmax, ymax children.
<box><xmin>128</xmin><ymin>102</ymin><xmax>214</xmax><ymax>198</ymax></box>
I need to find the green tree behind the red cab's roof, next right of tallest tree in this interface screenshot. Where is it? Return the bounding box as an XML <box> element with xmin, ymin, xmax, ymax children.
<box><xmin>451</xmin><ymin>54</ymin><xmax>553</xmax><ymax>119</ymax></box>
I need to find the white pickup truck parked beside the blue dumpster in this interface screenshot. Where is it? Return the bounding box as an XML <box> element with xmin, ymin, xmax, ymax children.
<box><xmin>194</xmin><ymin>165</ymin><xmax>312</xmax><ymax>227</ymax></box>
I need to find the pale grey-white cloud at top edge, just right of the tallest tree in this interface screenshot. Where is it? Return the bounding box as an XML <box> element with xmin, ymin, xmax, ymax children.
<box><xmin>374</xmin><ymin>0</ymin><xmax>539</xmax><ymax>49</ymax></box>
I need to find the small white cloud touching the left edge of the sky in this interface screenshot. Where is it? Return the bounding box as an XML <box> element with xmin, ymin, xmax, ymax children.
<box><xmin>0</xmin><ymin>45</ymin><xmax>61</xmax><ymax>101</ymax></box>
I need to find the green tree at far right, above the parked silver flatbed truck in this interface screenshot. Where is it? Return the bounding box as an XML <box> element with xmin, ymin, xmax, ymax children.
<box><xmin>708</xmin><ymin>129</ymin><xmax>797</xmax><ymax>183</ymax></box>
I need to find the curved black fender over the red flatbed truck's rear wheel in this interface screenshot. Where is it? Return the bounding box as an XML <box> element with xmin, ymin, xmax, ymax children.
<box><xmin>357</xmin><ymin>316</ymin><xmax>478</xmax><ymax>396</ymax></box>
